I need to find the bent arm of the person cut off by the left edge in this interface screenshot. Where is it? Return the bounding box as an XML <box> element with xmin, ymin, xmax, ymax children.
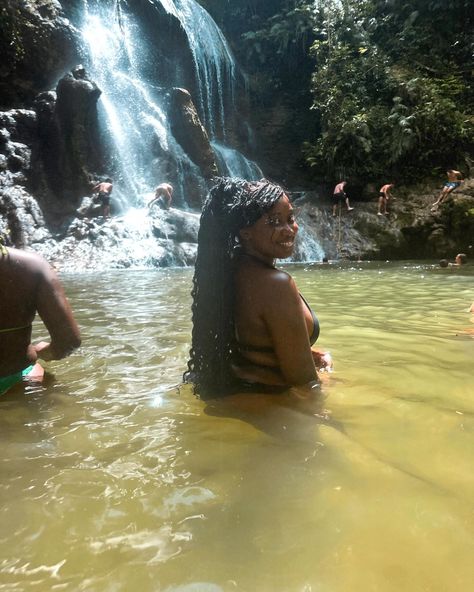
<box><xmin>35</xmin><ymin>259</ymin><xmax>81</xmax><ymax>361</ymax></box>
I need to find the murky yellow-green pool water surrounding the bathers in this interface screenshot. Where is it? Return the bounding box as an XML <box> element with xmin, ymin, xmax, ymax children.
<box><xmin>0</xmin><ymin>263</ymin><xmax>474</xmax><ymax>592</ymax></box>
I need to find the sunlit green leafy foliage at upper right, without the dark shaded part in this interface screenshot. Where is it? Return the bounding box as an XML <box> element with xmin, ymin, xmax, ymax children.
<box><xmin>304</xmin><ymin>0</ymin><xmax>474</xmax><ymax>178</ymax></box>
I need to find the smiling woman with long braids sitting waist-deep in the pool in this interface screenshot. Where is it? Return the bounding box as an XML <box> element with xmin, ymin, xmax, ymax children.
<box><xmin>185</xmin><ymin>178</ymin><xmax>331</xmax><ymax>399</ymax></box>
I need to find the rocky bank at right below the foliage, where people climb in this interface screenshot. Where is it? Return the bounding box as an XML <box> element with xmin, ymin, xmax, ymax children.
<box><xmin>297</xmin><ymin>180</ymin><xmax>474</xmax><ymax>259</ymax></box>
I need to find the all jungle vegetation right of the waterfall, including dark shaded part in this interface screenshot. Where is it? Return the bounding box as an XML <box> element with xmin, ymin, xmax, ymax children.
<box><xmin>202</xmin><ymin>0</ymin><xmax>474</xmax><ymax>180</ymax></box>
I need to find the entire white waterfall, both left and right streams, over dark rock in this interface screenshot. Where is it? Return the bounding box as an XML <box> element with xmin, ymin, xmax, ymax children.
<box><xmin>82</xmin><ymin>0</ymin><xmax>261</xmax><ymax>210</ymax></box>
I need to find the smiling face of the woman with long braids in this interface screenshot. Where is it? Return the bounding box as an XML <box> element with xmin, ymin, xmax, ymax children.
<box><xmin>240</xmin><ymin>195</ymin><xmax>298</xmax><ymax>261</ymax></box>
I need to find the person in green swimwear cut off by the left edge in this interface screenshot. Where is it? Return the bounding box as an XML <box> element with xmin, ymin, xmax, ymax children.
<box><xmin>0</xmin><ymin>242</ymin><xmax>81</xmax><ymax>395</ymax></box>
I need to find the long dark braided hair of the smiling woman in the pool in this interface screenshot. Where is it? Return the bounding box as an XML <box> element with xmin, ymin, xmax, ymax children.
<box><xmin>184</xmin><ymin>177</ymin><xmax>284</xmax><ymax>399</ymax></box>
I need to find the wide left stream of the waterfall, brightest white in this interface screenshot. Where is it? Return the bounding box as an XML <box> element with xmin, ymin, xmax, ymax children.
<box><xmin>82</xmin><ymin>5</ymin><xmax>207</xmax><ymax>209</ymax></box>
